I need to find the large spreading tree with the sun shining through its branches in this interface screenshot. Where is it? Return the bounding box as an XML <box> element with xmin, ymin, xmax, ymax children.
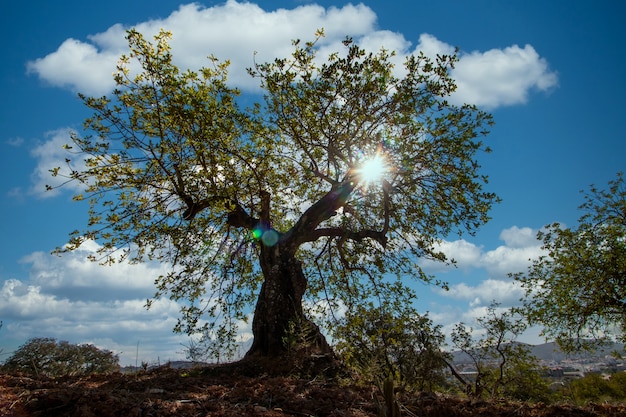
<box><xmin>52</xmin><ymin>30</ymin><xmax>496</xmax><ymax>356</ymax></box>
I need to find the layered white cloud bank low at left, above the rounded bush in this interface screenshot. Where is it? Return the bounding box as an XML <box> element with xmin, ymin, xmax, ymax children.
<box><xmin>0</xmin><ymin>242</ymin><xmax>188</xmax><ymax>364</ymax></box>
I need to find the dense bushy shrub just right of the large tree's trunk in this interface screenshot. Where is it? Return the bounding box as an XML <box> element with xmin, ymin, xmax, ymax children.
<box><xmin>334</xmin><ymin>290</ymin><xmax>447</xmax><ymax>391</ymax></box>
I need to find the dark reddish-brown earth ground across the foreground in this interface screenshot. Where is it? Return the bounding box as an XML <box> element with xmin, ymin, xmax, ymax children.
<box><xmin>0</xmin><ymin>356</ymin><xmax>626</xmax><ymax>417</ymax></box>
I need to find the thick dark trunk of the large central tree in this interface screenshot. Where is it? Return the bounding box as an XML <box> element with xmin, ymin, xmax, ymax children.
<box><xmin>246</xmin><ymin>242</ymin><xmax>332</xmax><ymax>357</ymax></box>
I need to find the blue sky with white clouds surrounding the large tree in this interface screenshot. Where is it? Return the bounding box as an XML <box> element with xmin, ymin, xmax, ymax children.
<box><xmin>0</xmin><ymin>0</ymin><xmax>626</xmax><ymax>364</ymax></box>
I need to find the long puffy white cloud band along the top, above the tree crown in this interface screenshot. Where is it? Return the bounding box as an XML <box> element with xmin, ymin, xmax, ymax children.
<box><xmin>27</xmin><ymin>0</ymin><xmax>557</xmax><ymax>109</ymax></box>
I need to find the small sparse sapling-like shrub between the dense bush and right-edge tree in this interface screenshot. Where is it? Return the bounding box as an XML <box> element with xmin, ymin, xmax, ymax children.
<box><xmin>451</xmin><ymin>302</ymin><xmax>548</xmax><ymax>401</ymax></box>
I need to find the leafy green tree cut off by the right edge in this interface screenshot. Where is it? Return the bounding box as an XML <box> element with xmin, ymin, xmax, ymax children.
<box><xmin>513</xmin><ymin>173</ymin><xmax>626</xmax><ymax>351</ymax></box>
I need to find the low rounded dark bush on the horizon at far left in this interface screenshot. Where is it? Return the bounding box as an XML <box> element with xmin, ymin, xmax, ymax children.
<box><xmin>3</xmin><ymin>338</ymin><xmax>120</xmax><ymax>378</ymax></box>
